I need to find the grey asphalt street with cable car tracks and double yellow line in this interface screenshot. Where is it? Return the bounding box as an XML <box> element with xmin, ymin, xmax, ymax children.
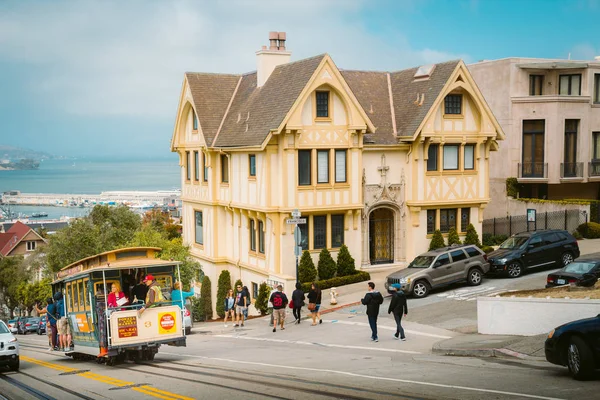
<box><xmin>0</xmin><ymin>312</ymin><xmax>600</xmax><ymax>400</ymax></box>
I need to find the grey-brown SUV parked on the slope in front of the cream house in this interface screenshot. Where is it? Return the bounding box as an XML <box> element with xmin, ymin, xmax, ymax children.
<box><xmin>385</xmin><ymin>245</ymin><xmax>490</xmax><ymax>298</ymax></box>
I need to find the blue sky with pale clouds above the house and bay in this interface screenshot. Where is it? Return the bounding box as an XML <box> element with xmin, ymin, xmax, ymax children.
<box><xmin>0</xmin><ymin>0</ymin><xmax>600</xmax><ymax>157</ymax></box>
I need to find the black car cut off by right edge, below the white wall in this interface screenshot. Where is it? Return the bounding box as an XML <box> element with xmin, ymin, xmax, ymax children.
<box><xmin>545</xmin><ymin>314</ymin><xmax>600</xmax><ymax>380</ymax></box>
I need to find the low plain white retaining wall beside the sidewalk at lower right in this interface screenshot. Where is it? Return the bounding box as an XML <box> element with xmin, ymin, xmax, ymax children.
<box><xmin>477</xmin><ymin>297</ymin><xmax>600</xmax><ymax>336</ymax></box>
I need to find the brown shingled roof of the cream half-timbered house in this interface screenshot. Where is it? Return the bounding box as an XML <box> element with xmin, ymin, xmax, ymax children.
<box><xmin>178</xmin><ymin>54</ymin><xmax>474</xmax><ymax>147</ymax></box>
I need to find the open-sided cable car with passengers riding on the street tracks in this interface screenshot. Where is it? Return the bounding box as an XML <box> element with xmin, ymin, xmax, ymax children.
<box><xmin>52</xmin><ymin>247</ymin><xmax>186</xmax><ymax>365</ymax></box>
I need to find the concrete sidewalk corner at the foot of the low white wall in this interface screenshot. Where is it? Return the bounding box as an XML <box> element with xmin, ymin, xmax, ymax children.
<box><xmin>431</xmin><ymin>334</ymin><xmax>547</xmax><ymax>361</ymax></box>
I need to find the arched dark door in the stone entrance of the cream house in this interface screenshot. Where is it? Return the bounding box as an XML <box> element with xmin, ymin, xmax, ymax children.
<box><xmin>369</xmin><ymin>208</ymin><xmax>394</xmax><ymax>264</ymax></box>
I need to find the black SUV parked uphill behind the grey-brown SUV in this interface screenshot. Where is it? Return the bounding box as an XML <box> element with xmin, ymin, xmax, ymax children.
<box><xmin>488</xmin><ymin>229</ymin><xmax>579</xmax><ymax>278</ymax></box>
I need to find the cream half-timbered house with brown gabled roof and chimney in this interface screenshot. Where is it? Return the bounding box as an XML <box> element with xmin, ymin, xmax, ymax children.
<box><xmin>171</xmin><ymin>32</ymin><xmax>504</xmax><ymax>312</ymax></box>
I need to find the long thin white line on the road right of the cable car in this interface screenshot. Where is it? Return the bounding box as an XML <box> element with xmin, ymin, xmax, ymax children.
<box><xmin>161</xmin><ymin>352</ymin><xmax>565</xmax><ymax>400</ymax></box>
